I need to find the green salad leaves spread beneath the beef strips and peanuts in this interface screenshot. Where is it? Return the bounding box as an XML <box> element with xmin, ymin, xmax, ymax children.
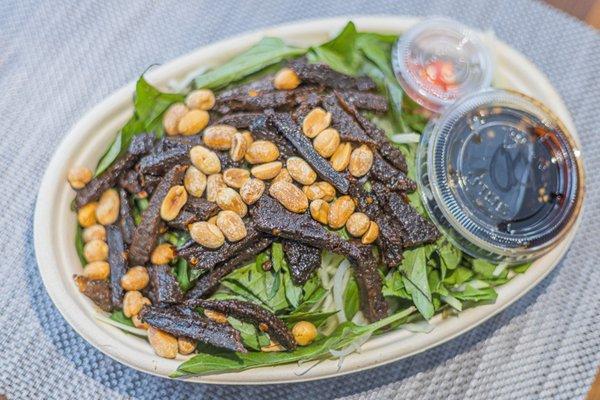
<box><xmin>76</xmin><ymin>22</ymin><xmax>529</xmax><ymax>377</ymax></box>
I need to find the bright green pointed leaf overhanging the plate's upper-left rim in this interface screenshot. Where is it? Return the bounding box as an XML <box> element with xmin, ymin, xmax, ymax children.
<box><xmin>95</xmin><ymin>76</ymin><xmax>185</xmax><ymax>176</ymax></box>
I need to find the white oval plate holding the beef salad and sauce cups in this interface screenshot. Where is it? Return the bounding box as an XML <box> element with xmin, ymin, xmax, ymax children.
<box><xmin>34</xmin><ymin>17</ymin><xmax>579</xmax><ymax>384</ymax></box>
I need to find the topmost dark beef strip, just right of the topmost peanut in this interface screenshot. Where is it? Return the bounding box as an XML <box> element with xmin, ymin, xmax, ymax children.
<box><xmin>290</xmin><ymin>59</ymin><xmax>376</xmax><ymax>91</ymax></box>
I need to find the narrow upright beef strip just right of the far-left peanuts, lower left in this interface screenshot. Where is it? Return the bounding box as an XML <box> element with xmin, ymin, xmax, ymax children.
<box><xmin>106</xmin><ymin>225</ymin><xmax>127</xmax><ymax>308</ymax></box>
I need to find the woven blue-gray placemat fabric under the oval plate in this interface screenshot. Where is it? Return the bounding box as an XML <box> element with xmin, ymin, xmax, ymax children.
<box><xmin>0</xmin><ymin>0</ymin><xmax>600</xmax><ymax>400</ymax></box>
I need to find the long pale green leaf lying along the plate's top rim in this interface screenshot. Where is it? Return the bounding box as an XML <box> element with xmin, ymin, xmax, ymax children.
<box><xmin>195</xmin><ymin>37</ymin><xmax>306</xmax><ymax>89</ymax></box>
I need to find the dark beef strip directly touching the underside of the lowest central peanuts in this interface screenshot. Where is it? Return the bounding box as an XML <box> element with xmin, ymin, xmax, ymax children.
<box><xmin>177</xmin><ymin>223</ymin><xmax>262</xmax><ymax>271</ymax></box>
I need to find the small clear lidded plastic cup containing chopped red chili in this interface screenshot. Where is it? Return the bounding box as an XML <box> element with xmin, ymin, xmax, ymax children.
<box><xmin>392</xmin><ymin>18</ymin><xmax>493</xmax><ymax>112</ymax></box>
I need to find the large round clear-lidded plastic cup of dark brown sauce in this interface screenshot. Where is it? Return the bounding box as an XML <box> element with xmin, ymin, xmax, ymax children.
<box><xmin>419</xmin><ymin>89</ymin><xmax>583</xmax><ymax>262</ymax></box>
